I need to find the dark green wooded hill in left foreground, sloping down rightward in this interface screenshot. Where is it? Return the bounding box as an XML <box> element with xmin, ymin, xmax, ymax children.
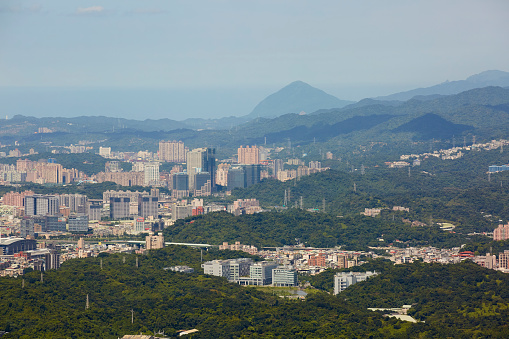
<box><xmin>0</xmin><ymin>246</ymin><xmax>410</xmax><ymax>339</ymax></box>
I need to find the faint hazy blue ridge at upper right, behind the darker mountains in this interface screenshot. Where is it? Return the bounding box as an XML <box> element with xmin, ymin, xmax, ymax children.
<box><xmin>374</xmin><ymin>70</ymin><xmax>509</xmax><ymax>101</ymax></box>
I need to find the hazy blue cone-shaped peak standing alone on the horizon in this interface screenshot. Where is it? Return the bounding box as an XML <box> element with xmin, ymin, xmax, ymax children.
<box><xmin>247</xmin><ymin>81</ymin><xmax>354</xmax><ymax>119</ymax></box>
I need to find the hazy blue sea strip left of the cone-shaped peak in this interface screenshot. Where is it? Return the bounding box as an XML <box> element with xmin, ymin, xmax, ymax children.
<box><xmin>0</xmin><ymin>87</ymin><xmax>274</xmax><ymax>120</ymax></box>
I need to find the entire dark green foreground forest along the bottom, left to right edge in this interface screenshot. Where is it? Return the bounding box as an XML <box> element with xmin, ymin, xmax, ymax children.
<box><xmin>0</xmin><ymin>246</ymin><xmax>509</xmax><ymax>339</ymax></box>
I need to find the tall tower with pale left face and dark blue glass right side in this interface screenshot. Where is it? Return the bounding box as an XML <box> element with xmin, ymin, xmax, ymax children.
<box><xmin>186</xmin><ymin>148</ymin><xmax>216</xmax><ymax>191</ymax></box>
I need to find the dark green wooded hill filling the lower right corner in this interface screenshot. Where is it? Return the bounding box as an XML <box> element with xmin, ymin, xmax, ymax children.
<box><xmin>309</xmin><ymin>261</ymin><xmax>509</xmax><ymax>338</ymax></box>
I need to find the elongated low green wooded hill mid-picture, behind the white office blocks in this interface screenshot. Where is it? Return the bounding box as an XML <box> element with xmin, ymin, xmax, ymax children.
<box><xmin>164</xmin><ymin>208</ymin><xmax>480</xmax><ymax>250</ymax></box>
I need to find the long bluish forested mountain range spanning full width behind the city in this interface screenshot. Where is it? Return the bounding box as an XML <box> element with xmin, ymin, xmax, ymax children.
<box><xmin>0</xmin><ymin>87</ymin><xmax>509</xmax><ymax>157</ymax></box>
